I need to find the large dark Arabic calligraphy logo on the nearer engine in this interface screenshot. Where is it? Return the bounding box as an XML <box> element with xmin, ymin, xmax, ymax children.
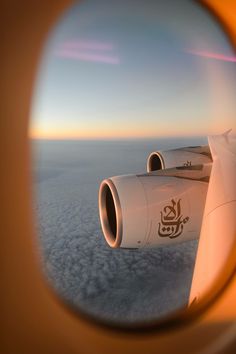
<box><xmin>158</xmin><ymin>199</ymin><xmax>189</xmax><ymax>238</ymax></box>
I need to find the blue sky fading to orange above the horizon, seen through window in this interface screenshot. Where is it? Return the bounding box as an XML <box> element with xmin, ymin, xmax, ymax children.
<box><xmin>29</xmin><ymin>0</ymin><xmax>236</xmax><ymax>139</ymax></box>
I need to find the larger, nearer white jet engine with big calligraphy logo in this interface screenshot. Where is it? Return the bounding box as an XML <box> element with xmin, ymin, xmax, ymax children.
<box><xmin>99</xmin><ymin>164</ymin><xmax>211</xmax><ymax>248</ymax></box>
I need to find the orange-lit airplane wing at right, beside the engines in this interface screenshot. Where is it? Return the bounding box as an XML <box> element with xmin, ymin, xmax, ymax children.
<box><xmin>189</xmin><ymin>131</ymin><xmax>236</xmax><ymax>305</ymax></box>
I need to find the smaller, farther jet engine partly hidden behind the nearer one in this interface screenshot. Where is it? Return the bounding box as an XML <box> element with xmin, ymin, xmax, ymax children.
<box><xmin>147</xmin><ymin>145</ymin><xmax>212</xmax><ymax>172</ymax></box>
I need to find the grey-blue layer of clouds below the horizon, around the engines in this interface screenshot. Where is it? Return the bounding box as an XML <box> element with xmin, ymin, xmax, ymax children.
<box><xmin>34</xmin><ymin>140</ymin><xmax>203</xmax><ymax>322</ymax></box>
